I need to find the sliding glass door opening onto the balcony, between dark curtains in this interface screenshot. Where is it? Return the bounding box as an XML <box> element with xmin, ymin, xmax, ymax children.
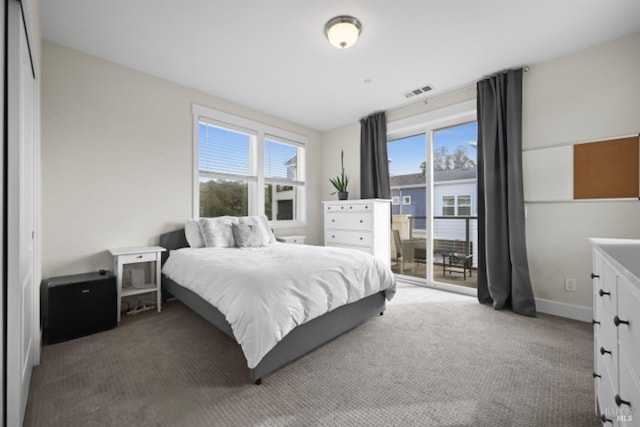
<box><xmin>388</xmin><ymin>121</ymin><xmax>478</xmax><ymax>288</ymax></box>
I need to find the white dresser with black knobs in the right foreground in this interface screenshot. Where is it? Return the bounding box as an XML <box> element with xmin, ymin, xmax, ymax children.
<box><xmin>590</xmin><ymin>239</ymin><xmax>640</xmax><ymax>427</ymax></box>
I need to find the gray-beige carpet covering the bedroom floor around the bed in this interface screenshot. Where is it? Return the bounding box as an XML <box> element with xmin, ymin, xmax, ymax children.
<box><xmin>25</xmin><ymin>285</ymin><xmax>599</xmax><ymax>427</ymax></box>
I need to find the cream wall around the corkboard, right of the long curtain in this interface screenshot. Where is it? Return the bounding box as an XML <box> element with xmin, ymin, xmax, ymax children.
<box><xmin>523</xmin><ymin>33</ymin><xmax>640</xmax><ymax>307</ymax></box>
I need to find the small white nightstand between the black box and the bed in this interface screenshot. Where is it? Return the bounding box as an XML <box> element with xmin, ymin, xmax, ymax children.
<box><xmin>109</xmin><ymin>246</ymin><xmax>166</xmax><ymax>322</ymax></box>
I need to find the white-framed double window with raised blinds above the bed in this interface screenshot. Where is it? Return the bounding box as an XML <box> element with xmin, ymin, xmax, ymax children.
<box><xmin>193</xmin><ymin>105</ymin><xmax>307</xmax><ymax>226</ymax></box>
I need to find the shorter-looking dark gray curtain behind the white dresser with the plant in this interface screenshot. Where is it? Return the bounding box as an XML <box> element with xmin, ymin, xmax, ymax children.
<box><xmin>360</xmin><ymin>112</ymin><xmax>391</xmax><ymax>199</ymax></box>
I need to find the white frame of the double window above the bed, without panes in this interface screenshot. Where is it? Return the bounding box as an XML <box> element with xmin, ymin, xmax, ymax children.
<box><xmin>191</xmin><ymin>104</ymin><xmax>309</xmax><ymax>228</ymax></box>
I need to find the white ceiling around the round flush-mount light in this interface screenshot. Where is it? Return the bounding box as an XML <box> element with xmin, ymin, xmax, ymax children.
<box><xmin>40</xmin><ymin>0</ymin><xmax>640</xmax><ymax>131</ymax></box>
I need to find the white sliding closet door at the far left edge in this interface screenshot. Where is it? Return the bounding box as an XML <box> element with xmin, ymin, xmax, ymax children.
<box><xmin>6</xmin><ymin>0</ymin><xmax>38</xmax><ymax>425</ymax></box>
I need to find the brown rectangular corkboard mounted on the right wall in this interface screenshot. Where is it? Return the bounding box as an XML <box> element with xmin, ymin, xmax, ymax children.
<box><xmin>573</xmin><ymin>136</ymin><xmax>640</xmax><ymax>200</ymax></box>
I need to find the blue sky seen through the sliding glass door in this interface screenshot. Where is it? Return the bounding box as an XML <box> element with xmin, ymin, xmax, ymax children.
<box><xmin>387</xmin><ymin>122</ymin><xmax>478</xmax><ymax>175</ymax></box>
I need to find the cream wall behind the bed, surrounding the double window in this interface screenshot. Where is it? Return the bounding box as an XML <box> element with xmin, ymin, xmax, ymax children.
<box><xmin>42</xmin><ymin>42</ymin><xmax>321</xmax><ymax>277</ymax></box>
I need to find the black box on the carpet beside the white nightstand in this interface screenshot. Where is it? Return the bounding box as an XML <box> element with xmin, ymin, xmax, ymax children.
<box><xmin>40</xmin><ymin>270</ymin><xmax>118</xmax><ymax>344</ymax></box>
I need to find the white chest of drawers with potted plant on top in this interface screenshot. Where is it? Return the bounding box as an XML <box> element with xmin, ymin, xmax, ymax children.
<box><xmin>322</xmin><ymin>199</ymin><xmax>391</xmax><ymax>264</ymax></box>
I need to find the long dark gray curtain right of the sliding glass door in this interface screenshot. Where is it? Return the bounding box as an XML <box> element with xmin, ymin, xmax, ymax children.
<box><xmin>477</xmin><ymin>69</ymin><xmax>536</xmax><ymax>316</ymax></box>
